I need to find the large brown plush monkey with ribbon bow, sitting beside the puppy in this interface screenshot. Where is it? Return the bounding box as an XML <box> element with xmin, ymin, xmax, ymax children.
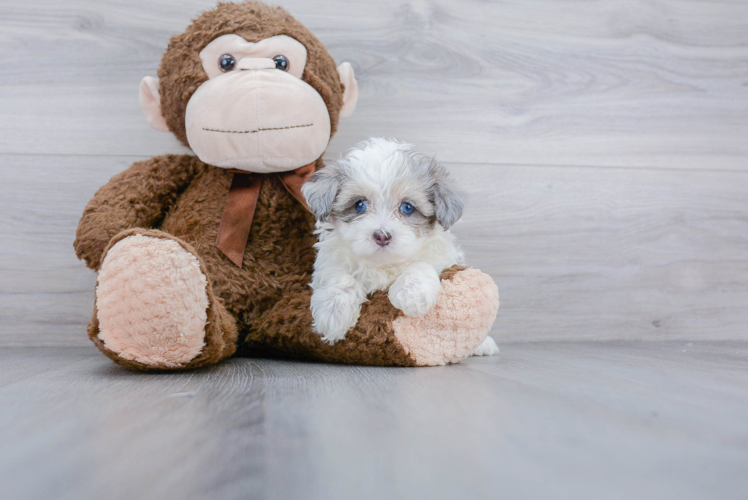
<box><xmin>75</xmin><ymin>2</ymin><xmax>498</xmax><ymax>370</ymax></box>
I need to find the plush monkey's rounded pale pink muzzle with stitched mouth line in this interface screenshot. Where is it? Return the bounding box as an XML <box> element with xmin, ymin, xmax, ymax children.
<box><xmin>185</xmin><ymin>66</ymin><xmax>330</xmax><ymax>173</ymax></box>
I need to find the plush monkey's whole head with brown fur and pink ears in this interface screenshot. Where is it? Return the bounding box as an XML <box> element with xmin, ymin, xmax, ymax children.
<box><xmin>140</xmin><ymin>2</ymin><xmax>357</xmax><ymax>173</ymax></box>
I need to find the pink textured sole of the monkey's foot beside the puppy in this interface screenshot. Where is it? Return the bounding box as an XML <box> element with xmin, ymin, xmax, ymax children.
<box><xmin>392</xmin><ymin>267</ymin><xmax>499</xmax><ymax>366</ymax></box>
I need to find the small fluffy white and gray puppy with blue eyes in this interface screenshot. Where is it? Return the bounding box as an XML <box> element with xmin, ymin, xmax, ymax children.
<box><xmin>302</xmin><ymin>138</ymin><xmax>498</xmax><ymax>354</ymax></box>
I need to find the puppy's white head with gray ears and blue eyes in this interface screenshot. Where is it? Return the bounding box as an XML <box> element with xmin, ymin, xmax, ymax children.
<box><xmin>302</xmin><ymin>139</ymin><xmax>465</xmax><ymax>264</ymax></box>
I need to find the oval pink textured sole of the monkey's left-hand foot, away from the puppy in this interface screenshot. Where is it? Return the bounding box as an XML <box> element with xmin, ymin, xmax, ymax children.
<box><xmin>96</xmin><ymin>234</ymin><xmax>209</xmax><ymax>367</ymax></box>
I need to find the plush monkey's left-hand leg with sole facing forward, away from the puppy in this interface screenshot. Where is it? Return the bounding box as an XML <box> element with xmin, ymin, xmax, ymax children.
<box><xmin>89</xmin><ymin>229</ymin><xmax>237</xmax><ymax>370</ymax></box>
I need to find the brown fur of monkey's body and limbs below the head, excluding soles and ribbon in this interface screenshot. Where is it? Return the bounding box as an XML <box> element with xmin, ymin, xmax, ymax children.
<box><xmin>75</xmin><ymin>155</ymin><xmax>424</xmax><ymax>370</ymax></box>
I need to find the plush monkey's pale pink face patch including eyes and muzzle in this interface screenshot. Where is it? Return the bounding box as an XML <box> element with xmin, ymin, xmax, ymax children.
<box><xmin>185</xmin><ymin>35</ymin><xmax>330</xmax><ymax>173</ymax></box>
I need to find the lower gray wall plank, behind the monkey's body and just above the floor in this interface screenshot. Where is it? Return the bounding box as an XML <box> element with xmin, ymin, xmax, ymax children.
<box><xmin>0</xmin><ymin>155</ymin><xmax>748</xmax><ymax>345</ymax></box>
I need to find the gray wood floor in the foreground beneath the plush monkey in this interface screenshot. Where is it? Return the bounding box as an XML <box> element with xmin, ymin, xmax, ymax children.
<box><xmin>0</xmin><ymin>342</ymin><xmax>748</xmax><ymax>500</ymax></box>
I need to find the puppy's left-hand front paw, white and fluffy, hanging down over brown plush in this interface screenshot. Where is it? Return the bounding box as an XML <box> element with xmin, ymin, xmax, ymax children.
<box><xmin>311</xmin><ymin>288</ymin><xmax>361</xmax><ymax>345</ymax></box>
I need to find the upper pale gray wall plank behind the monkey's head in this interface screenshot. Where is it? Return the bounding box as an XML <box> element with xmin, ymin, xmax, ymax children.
<box><xmin>0</xmin><ymin>0</ymin><xmax>748</xmax><ymax>170</ymax></box>
